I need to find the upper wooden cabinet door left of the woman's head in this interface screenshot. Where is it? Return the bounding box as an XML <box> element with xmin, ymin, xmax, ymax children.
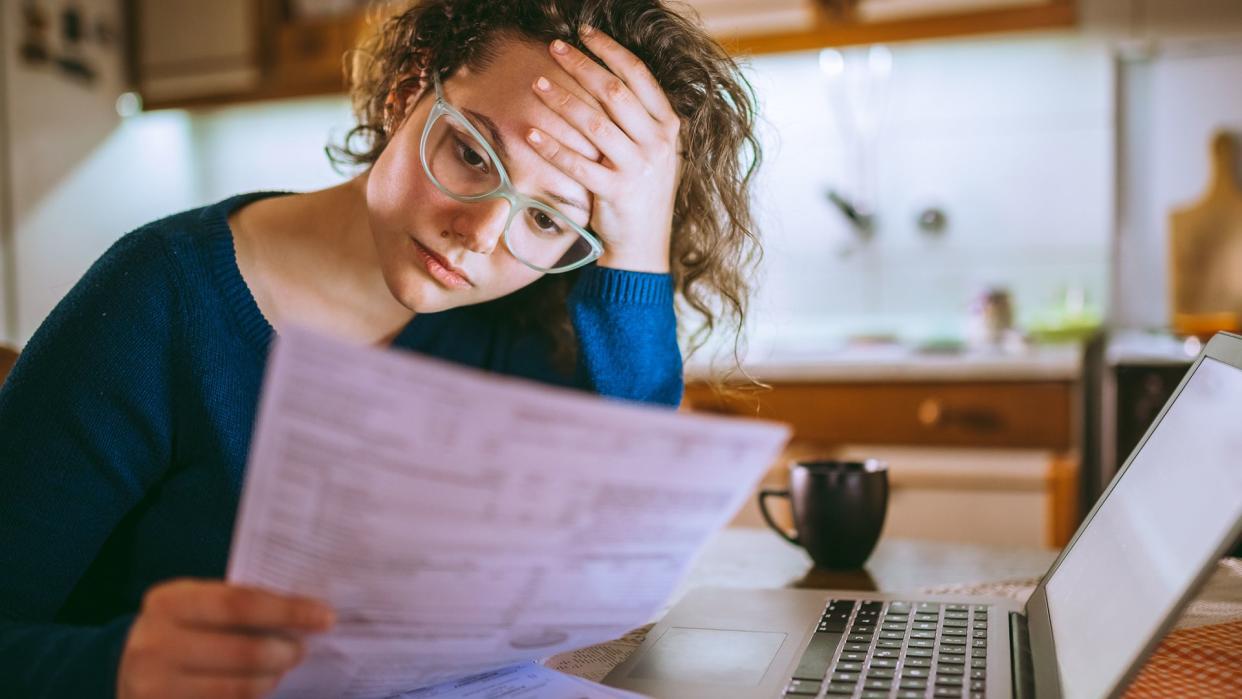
<box><xmin>134</xmin><ymin>0</ymin><xmax>262</xmax><ymax>106</ymax></box>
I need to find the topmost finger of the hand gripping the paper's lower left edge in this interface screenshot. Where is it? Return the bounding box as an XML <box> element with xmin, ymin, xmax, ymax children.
<box><xmin>143</xmin><ymin>580</ymin><xmax>333</xmax><ymax>632</ymax></box>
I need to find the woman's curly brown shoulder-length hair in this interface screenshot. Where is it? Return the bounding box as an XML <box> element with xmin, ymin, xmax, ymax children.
<box><xmin>329</xmin><ymin>0</ymin><xmax>763</xmax><ymax>382</ymax></box>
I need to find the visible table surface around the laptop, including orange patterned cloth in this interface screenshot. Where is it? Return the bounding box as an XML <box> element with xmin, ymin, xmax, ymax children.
<box><xmin>546</xmin><ymin>526</ymin><xmax>1242</xmax><ymax>699</ymax></box>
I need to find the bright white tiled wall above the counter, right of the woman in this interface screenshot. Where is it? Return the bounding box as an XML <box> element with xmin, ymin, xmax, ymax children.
<box><xmin>735</xmin><ymin>35</ymin><xmax>1115</xmax><ymax>350</ymax></box>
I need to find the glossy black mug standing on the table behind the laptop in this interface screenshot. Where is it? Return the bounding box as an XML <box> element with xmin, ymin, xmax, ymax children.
<box><xmin>759</xmin><ymin>459</ymin><xmax>888</xmax><ymax>570</ymax></box>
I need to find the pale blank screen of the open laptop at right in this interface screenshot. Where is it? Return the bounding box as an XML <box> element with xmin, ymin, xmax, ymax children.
<box><xmin>1045</xmin><ymin>358</ymin><xmax>1242</xmax><ymax>698</ymax></box>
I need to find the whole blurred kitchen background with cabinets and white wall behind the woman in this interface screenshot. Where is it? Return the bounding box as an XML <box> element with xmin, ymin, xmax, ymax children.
<box><xmin>0</xmin><ymin>0</ymin><xmax>1242</xmax><ymax>553</ymax></box>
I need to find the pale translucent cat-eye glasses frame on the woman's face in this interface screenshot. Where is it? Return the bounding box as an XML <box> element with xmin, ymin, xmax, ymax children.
<box><xmin>419</xmin><ymin>76</ymin><xmax>604</xmax><ymax>274</ymax></box>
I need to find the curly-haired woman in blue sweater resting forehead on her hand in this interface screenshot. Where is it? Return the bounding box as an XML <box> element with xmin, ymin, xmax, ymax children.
<box><xmin>0</xmin><ymin>0</ymin><xmax>758</xmax><ymax>698</ymax></box>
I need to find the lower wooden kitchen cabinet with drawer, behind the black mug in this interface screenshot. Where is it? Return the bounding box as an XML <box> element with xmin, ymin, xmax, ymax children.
<box><xmin>684</xmin><ymin>380</ymin><xmax>1081</xmax><ymax>546</ymax></box>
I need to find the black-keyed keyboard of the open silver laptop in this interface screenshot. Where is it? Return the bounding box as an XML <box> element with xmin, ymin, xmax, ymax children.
<box><xmin>785</xmin><ymin>600</ymin><xmax>987</xmax><ymax>699</ymax></box>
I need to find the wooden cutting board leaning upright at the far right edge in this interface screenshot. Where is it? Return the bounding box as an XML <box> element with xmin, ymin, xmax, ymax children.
<box><xmin>1169</xmin><ymin>133</ymin><xmax>1242</xmax><ymax>334</ymax></box>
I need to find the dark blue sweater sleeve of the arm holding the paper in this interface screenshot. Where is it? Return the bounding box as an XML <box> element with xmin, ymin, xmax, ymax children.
<box><xmin>0</xmin><ymin>230</ymin><xmax>180</xmax><ymax>698</ymax></box>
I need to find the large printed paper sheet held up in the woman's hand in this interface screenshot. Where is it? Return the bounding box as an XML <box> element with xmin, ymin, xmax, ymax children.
<box><xmin>229</xmin><ymin>329</ymin><xmax>789</xmax><ymax>698</ymax></box>
